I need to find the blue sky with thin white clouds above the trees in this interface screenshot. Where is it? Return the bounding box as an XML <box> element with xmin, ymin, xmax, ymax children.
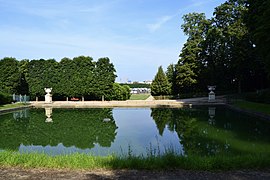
<box><xmin>0</xmin><ymin>0</ymin><xmax>225</xmax><ymax>82</ymax></box>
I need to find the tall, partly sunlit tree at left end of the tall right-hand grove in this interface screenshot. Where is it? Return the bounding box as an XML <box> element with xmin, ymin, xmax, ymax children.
<box><xmin>175</xmin><ymin>13</ymin><xmax>209</xmax><ymax>93</ymax></box>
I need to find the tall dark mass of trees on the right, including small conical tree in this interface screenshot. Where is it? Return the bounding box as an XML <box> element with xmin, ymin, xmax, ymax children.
<box><xmin>152</xmin><ymin>0</ymin><xmax>270</xmax><ymax>95</ymax></box>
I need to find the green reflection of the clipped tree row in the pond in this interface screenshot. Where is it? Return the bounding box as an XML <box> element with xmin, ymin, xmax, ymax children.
<box><xmin>0</xmin><ymin>109</ymin><xmax>117</xmax><ymax>149</ymax></box>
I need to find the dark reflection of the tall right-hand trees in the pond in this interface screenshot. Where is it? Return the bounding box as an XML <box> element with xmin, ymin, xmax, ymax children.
<box><xmin>151</xmin><ymin>108</ymin><xmax>270</xmax><ymax>156</ymax></box>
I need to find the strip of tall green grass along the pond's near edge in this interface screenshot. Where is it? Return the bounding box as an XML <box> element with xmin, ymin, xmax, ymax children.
<box><xmin>0</xmin><ymin>151</ymin><xmax>270</xmax><ymax>170</ymax></box>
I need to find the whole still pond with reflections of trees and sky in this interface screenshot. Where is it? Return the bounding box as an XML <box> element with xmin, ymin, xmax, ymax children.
<box><xmin>0</xmin><ymin>106</ymin><xmax>270</xmax><ymax>156</ymax></box>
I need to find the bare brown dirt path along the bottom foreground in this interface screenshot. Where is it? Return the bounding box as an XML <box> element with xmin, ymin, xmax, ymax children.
<box><xmin>0</xmin><ymin>167</ymin><xmax>270</xmax><ymax>180</ymax></box>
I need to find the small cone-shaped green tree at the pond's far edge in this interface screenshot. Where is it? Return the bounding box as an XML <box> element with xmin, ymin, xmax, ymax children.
<box><xmin>151</xmin><ymin>66</ymin><xmax>171</xmax><ymax>96</ymax></box>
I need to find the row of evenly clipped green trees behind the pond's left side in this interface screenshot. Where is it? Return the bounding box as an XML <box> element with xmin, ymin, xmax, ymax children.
<box><xmin>0</xmin><ymin>56</ymin><xmax>130</xmax><ymax>100</ymax></box>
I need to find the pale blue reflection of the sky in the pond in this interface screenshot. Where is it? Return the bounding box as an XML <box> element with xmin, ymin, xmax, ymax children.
<box><xmin>19</xmin><ymin>108</ymin><xmax>183</xmax><ymax>155</ymax></box>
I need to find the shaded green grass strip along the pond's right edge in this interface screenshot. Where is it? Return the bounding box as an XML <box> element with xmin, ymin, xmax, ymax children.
<box><xmin>233</xmin><ymin>100</ymin><xmax>270</xmax><ymax>115</ymax></box>
